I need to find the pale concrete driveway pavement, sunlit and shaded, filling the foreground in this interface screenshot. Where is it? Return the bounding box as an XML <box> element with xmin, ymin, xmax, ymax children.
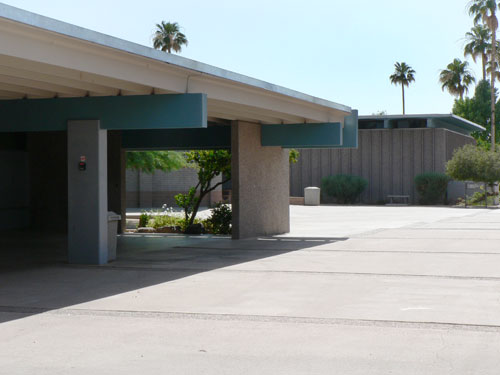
<box><xmin>0</xmin><ymin>206</ymin><xmax>500</xmax><ymax>375</ymax></box>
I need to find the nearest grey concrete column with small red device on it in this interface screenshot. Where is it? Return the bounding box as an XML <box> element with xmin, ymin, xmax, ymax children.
<box><xmin>68</xmin><ymin>120</ymin><xmax>108</xmax><ymax>264</ymax></box>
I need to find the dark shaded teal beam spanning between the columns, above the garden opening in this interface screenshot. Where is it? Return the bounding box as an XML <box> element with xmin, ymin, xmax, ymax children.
<box><xmin>122</xmin><ymin>126</ymin><xmax>231</xmax><ymax>151</ymax></box>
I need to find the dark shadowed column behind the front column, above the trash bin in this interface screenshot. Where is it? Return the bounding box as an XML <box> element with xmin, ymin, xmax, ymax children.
<box><xmin>108</xmin><ymin>130</ymin><xmax>127</xmax><ymax>233</ymax></box>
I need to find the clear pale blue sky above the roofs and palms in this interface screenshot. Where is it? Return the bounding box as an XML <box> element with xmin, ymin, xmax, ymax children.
<box><xmin>3</xmin><ymin>0</ymin><xmax>481</xmax><ymax>115</ymax></box>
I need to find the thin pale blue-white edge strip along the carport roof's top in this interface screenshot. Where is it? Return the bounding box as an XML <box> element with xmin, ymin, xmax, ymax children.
<box><xmin>0</xmin><ymin>3</ymin><xmax>352</xmax><ymax>113</ymax></box>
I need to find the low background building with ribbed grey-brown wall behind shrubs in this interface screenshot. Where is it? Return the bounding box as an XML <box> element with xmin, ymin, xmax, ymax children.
<box><xmin>290</xmin><ymin>114</ymin><xmax>484</xmax><ymax>204</ymax></box>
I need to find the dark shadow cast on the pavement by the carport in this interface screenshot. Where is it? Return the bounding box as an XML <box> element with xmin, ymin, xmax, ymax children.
<box><xmin>0</xmin><ymin>231</ymin><xmax>346</xmax><ymax>322</ymax></box>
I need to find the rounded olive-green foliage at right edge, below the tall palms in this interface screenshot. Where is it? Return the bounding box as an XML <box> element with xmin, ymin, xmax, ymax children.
<box><xmin>446</xmin><ymin>145</ymin><xmax>500</xmax><ymax>184</ymax></box>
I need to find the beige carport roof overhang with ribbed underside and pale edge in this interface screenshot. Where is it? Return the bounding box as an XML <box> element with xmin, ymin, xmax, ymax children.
<box><xmin>0</xmin><ymin>4</ymin><xmax>351</xmax><ymax>124</ymax></box>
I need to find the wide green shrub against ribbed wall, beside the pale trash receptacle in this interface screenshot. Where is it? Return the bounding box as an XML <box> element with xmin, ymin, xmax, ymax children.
<box><xmin>321</xmin><ymin>174</ymin><xmax>368</xmax><ymax>204</ymax></box>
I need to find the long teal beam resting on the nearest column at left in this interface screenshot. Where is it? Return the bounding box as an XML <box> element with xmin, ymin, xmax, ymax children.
<box><xmin>0</xmin><ymin>94</ymin><xmax>207</xmax><ymax>132</ymax></box>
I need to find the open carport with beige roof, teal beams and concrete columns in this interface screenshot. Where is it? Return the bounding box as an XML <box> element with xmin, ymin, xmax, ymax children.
<box><xmin>0</xmin><ymin>3</ymin><xmax>358</xmax><ymax>264</ymax></box>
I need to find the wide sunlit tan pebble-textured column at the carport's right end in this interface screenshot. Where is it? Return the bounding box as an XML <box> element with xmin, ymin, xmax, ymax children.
<box><xmin>231</xmin><ymin>121</ymin><xmax>290</xmax><ymax>239</ymax></box>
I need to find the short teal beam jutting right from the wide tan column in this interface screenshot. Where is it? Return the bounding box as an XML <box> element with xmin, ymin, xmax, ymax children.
<box><xmin>261</xmin><ymin>122</ymin><xmax>342</xmax><ymax>148</ymax></box>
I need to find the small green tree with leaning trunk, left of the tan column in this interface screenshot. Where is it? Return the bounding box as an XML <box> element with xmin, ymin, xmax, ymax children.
<box><xmin>175</xmin><ymin>150</ymin><xmax>231</xmax><ymax>229</ymax></box>
